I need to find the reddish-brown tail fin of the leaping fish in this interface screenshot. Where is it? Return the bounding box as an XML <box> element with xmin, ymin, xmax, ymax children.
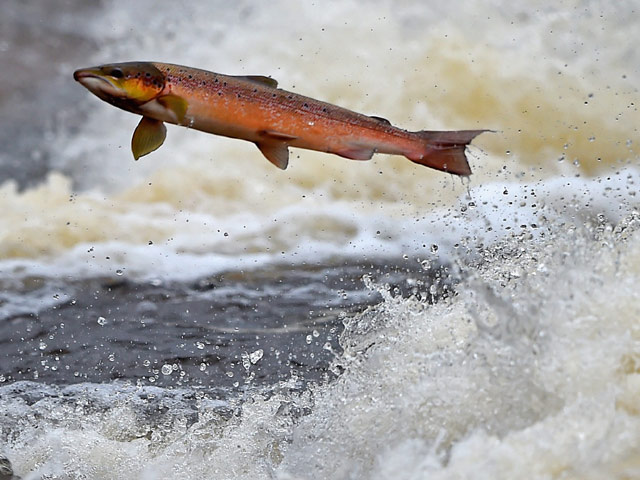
<box><xmin>407</xmin><ymin>130</ymin><xmax>488</xmax><ymax>176</ymax></box>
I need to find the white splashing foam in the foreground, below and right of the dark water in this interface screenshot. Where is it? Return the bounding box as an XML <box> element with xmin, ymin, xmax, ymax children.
<box><xmin>4</xmin><ymin>203</ymin><xmax>640</xmax><ymax>479</ymax></box>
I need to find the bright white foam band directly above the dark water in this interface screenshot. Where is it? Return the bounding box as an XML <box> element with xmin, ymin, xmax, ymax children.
<box><xmin>0</xmin><ymin>169</ymin><xmax>640</xmax><ymax>280</ymax></box>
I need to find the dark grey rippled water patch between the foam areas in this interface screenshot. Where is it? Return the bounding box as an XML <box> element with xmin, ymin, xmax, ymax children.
<box><xmin>0</xmin><ymin>261</ymin><xmax>449</xmax><ymax>387</ymax></box>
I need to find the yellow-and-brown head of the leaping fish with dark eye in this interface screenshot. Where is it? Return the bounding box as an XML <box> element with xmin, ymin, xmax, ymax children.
<box><xmin>73</xmin><ymin>62</ymin><xmax>165</xmax><ymax>107</ymax></box>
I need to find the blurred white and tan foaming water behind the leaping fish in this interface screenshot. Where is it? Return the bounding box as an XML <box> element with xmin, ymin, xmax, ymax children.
<box><xmin>0</xmin><ymin>0</ymin><xmax>640</xmax><ymax>279</ymax></box>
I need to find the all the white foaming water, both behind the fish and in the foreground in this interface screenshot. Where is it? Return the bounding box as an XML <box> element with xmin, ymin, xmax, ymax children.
<box><xmin>0</xmin><ymin>0</ymin><xmax>640</xmax><ymax>479</ymax></box>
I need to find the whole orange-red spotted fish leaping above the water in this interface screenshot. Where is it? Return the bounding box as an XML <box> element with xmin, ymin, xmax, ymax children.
<box><xmin>73</xmin><ymin>62</ymin><xmax>487</xmax><ymax>175</ymax></box>
